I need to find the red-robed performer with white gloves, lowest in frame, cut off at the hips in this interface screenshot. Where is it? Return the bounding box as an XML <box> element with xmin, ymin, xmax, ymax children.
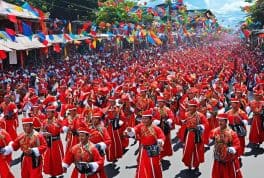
<box><xmin>62</xmin><ymin>127</ymin><xmax>106</xmax><ymax>178</ymax></box>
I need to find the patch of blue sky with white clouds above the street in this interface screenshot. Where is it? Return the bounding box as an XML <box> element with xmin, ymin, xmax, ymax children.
<box><xmin>184</xmin><ymin>0</ymin><xmax>254</xmax><ymax>28</ymax></box>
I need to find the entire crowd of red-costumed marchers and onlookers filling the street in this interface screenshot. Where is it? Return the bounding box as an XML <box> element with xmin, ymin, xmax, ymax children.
<box><xmin>0</xmin><ymin>34</ymin><xmax>264</xmax><ymax>178</ymax></box>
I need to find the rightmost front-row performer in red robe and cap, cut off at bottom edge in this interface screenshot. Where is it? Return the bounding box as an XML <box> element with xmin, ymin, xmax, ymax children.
<box><xmin>210</xmin><ymin>113</ymin><xmax>242</xmax><ymax>178</ymax></box>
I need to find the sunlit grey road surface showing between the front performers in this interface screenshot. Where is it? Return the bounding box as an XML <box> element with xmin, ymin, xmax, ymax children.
<box><xmin>12</xmin><ymin>117</ymin><xmax>264</xmax><ymax>178</ymax></box>
